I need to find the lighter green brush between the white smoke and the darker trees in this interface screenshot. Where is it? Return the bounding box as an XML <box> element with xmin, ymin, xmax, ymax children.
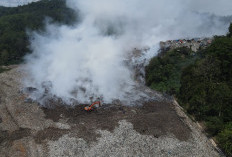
<box><xmin>146</xmin><ymin>47</ymin><xmax>200</xmax><ymax>94</ymax></box>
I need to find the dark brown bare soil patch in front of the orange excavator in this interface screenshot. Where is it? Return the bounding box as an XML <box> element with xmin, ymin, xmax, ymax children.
<box><xmin>43</xmin><ymin>102</ymin><xmax>191</xmax><ymax>142</ymax></box>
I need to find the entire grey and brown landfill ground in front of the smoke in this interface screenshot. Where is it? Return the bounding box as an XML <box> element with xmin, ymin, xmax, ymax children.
<box><xmin>0</xmin><ymin>66</ymin><xmax>219</xmax><ymax>157</ymax></box>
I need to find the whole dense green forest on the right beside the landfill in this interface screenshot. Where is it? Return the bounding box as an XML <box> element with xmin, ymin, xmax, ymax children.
<box><xmin>146</xmin><ymin>24</ymin><xmax>232</xmax><ymax>156</ymax></box>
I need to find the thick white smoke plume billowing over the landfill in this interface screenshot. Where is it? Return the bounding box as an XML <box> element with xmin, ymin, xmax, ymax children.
<box><xmin>25</xmin><ymin>0</ymin><xmax>232</xmax><ymax>103</ymax></box>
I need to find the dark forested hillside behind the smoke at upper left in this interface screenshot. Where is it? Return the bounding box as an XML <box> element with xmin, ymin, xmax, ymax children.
<box><xmin>0</xmin><ymin>0</ymin><xmax>77</xmax><ymax>65</ymax></box>
